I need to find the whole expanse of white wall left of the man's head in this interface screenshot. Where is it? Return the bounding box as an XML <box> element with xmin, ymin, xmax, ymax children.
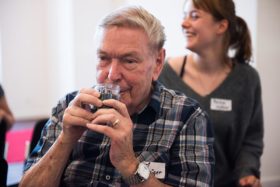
<box><xmin>0</xmin><ymin>0</ymin><xmax>117</xmax><ymax>120</ymax></box>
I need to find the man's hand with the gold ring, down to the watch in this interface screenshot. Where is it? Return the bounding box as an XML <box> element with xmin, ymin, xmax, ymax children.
<box><xmin>87</xmin><ymin>99</ymin><xmax>138</xmax><ymax>176</ymax></box>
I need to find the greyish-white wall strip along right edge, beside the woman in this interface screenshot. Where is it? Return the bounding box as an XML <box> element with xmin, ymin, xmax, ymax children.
<box><xmin>256</xmin><ymin>0</ymin><xmax>280</xmax><ymax>187</ymax></box>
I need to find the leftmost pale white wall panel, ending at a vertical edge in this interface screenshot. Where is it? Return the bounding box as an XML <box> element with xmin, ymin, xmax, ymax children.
<box><xmin>0</xmin><ymin>0</ymin><xmax>50</xmax><ymax>118</ymax></box>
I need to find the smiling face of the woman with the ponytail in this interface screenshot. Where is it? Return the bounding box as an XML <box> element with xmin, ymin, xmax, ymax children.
<box><xmin>182</xmin><ymin>0</ymin><xmax>224</xmax><ymax>53</ymax></box>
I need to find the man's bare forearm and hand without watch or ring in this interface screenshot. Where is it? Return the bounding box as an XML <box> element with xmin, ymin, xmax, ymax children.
<box><xmin>20</xmin><ymin>89</ymin><xmax>101</xmax><ymax>187</ymax></box>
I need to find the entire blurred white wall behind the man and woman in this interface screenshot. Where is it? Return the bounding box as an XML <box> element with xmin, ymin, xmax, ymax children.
<box><xmin>0</xmin><ymin>0</ymin><xmax>280</xmax><ymax>187</ymax></box>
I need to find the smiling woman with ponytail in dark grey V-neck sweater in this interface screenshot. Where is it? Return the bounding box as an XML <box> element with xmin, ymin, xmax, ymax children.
<box><xmin>160</xmin><ymin>0</ymin><xmax>264</xmax><ymax>187</ymax></box>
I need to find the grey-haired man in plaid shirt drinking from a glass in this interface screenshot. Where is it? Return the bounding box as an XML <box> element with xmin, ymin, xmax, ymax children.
<box><xmin>20</xmin><ymin>7</ymin><xmax>214</xmax><ymax>187</ymax></box>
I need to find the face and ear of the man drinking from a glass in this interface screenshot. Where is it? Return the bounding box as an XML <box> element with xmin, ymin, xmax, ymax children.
<box><xmin>97</xmin><ymin>27</ymin><xmax>164</xmax><ymax>114</ymax></box>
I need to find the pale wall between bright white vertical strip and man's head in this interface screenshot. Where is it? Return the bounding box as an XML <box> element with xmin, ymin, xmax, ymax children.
<box><xmin>73</xmin><ymin>0</ymin><xmax>117</xmax><ymax>88</ymax></box>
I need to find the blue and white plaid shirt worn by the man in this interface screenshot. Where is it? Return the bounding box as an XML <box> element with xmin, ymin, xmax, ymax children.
<box><xmin>25</xmin><ymin>82</ymin><xmax>214</xmax><ymax>187</ymax></box>
